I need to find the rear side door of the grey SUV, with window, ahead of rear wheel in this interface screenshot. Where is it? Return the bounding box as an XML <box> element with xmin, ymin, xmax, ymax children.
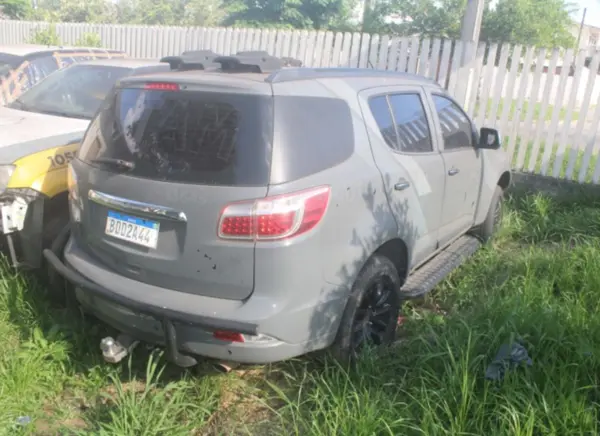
<box><xmin>360</xmin><ymin>86</ymin><xmax>445</xmax><ymax>267</ymax></box>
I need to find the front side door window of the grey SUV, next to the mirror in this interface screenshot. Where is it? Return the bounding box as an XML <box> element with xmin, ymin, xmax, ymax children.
<box><xmin>433</xmin><ymin>94</ymin><xmax>473</xmax><ymax>150</ymax></box>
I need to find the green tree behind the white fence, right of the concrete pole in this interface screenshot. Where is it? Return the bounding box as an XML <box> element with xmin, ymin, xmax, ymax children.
<box><xmin>481</xmin><ymin>0</ymin><xmax>575</xmax><ymax>48</ymax></box>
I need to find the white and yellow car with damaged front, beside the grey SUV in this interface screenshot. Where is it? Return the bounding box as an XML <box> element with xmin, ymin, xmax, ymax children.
<box><xmin>0</xmin><ymin>58</ymin><xmax>170</xmax><ymax>268</ymax></box>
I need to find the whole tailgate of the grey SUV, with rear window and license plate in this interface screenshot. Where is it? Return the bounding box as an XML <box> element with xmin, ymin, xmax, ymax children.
<box><xmin>73</xmin><ymin>81</ymin><xmax>272</xmax><ymax>300</ymax></box>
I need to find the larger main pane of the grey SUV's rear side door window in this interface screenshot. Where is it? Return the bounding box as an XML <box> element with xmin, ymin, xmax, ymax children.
<box><xmin>388</xmin><ymin>94</ymin><xmax>433</xmax><ymax>153</ymax></box>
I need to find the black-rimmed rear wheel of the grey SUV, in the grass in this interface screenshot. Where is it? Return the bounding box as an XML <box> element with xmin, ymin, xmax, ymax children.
<box><xmin>332</xmin><ymin>255</ymin><xmax>402</xmax><ymax>363</ymax></box>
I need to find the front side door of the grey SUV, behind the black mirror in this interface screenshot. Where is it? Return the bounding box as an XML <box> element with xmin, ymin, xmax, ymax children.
<box><xmin>431</xmin><ymin>93</ymin><xmax>482</xmax><ymax>246</ymax></box>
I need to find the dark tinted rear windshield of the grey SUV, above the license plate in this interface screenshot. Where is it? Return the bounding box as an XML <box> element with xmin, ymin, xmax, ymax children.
<box><xmin>79</xmin><ymin>88</ymin><xmax>273</xmax><ymax>186</ymax></box>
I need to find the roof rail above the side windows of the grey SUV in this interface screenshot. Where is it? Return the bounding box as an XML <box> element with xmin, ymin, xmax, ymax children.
<box><xmin>266</xmin><ymin>67</ymin><xmax>437</xmax><ymax>83</ymax></box>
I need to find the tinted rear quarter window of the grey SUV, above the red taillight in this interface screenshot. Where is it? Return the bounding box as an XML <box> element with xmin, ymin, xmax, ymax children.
<box><xmin>271</xmin><ymin>96</ymin><xmax>354</xmax><ymax>184</ymax></box>
